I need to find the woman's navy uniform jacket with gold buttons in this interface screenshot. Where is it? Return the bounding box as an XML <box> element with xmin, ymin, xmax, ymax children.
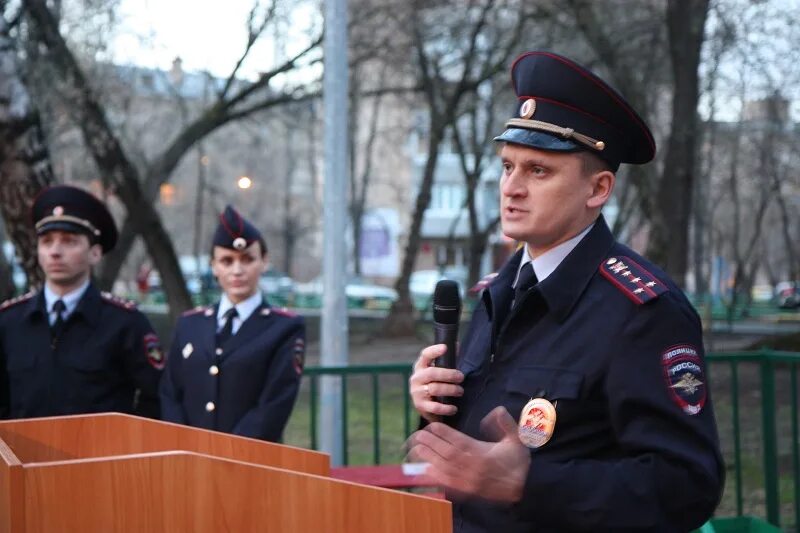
<box><xmin>161</xmin><ymin>304</ymin><xmax>305</xmax><ymax>442</ymax></box>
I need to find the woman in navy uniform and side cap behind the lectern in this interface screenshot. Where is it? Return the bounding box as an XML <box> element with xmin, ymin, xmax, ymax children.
<box><xmin>161</xmin><ymin>206</ymin><xmax>305</xmax><ymax>442</ymax></box>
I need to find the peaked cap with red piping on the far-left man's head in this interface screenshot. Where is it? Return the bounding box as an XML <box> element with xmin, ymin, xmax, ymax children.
<box><xmin>31</xmin><ymin>185</ymin><xmax>117</xmax><ymax>253</ymax></box>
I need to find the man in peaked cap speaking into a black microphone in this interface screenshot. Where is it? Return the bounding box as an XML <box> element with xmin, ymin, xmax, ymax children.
<box><xmin>410</xmin><ymin>52</ymin><xmax>723</xmax><ymax>532</ymax></box>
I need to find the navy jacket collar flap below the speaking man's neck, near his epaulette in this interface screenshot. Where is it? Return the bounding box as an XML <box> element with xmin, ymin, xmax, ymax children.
<box><xmin>537</xmin><ymin>215</ymin><xmax>615</xmax><ymax>322</ymax></box>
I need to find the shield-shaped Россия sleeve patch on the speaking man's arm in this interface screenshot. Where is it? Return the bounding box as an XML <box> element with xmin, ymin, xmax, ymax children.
<box><xmin>661</xmin><ymin>344</ymin><xmax>706</xmax><ymax>415</ymax></box>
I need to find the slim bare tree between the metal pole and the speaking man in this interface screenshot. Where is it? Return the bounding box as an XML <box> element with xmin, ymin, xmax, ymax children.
<box><xmin>385</xmin><ymin>0</ymin><xmax>530</xmax><ymax>335</ymax></box>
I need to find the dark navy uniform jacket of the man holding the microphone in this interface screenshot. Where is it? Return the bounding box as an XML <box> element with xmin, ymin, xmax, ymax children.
<box><xmin>454</xmin><ymin>217</ymin><xmax>723</xmax><ymax>532</ymax></box>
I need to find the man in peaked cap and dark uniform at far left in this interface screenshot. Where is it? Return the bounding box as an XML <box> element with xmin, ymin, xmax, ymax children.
<box><xmin>0</xmin><ymin>185</ymin><xmax>164</xmax><ymax>418</ymax></box>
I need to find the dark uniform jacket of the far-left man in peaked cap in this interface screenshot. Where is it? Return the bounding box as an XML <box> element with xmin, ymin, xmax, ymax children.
<box><xmin>0</xmin><ymin>284</ymin><xmax>163</xmax><ymax>418</ymax></box>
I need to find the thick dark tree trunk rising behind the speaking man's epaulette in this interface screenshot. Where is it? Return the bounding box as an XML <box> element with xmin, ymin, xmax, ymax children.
<box><xmin>647</xmin><ymin>0</ymin><xmax>709</xmax><ymax>286</ymax></box>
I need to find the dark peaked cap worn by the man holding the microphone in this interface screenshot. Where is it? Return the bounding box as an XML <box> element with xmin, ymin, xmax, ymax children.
<box><xmin>494</xmin><ymin>51</ymin><xmax>656</xmax><ymax>170</ymax></box>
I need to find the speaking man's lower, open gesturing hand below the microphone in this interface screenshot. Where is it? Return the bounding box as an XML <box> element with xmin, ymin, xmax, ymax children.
<box><xmin>409</xmin><ymin>407</ymin><xmax>531</xmax><ymax>504</ymax></box>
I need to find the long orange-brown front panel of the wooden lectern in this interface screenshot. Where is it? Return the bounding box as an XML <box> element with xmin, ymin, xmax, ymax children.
<box><xmin>24</xmin><ymin>453</ymin><xmax>451</xmax><ymax>533</ymax></box>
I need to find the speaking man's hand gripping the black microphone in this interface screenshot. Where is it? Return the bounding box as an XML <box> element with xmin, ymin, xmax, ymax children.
<box><xmin>408</xmin><ymin>344</ymin><xmax>464</xmax><ymax>422</ymax></box>
